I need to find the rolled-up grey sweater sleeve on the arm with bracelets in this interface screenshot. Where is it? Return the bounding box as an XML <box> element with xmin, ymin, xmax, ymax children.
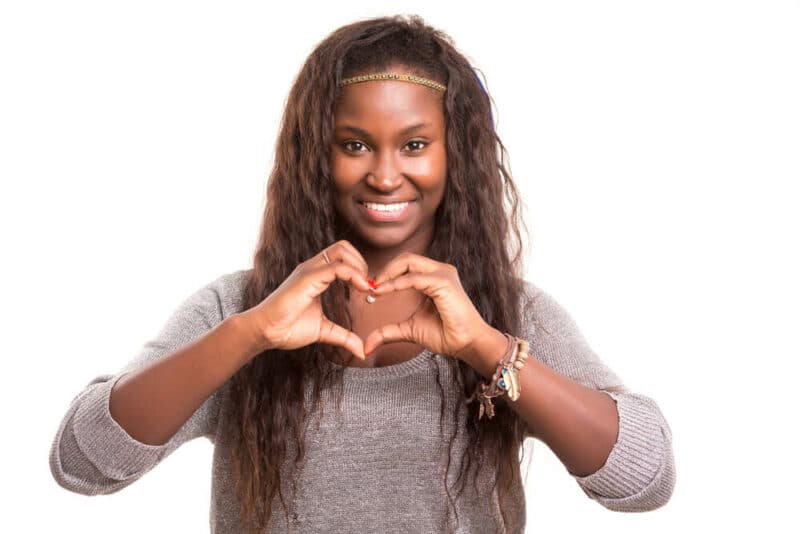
<box><xmin>523</xmin><ymin>281</ymin><xmax>675</xmax><ymax>512</ymax></box>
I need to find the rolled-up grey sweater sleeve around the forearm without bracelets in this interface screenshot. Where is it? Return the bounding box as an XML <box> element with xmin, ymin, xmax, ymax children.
<box><xmin>49</xmin><ymin>282</ymin><xmax>227</xmax><ymax>495</ymax></box>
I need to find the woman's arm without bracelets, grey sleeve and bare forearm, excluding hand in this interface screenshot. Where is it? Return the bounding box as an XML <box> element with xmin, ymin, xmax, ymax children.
<box><xmin>50</xmin><ymin>273</ymin><xmax>266</xmax><ymax>495</ymax></box>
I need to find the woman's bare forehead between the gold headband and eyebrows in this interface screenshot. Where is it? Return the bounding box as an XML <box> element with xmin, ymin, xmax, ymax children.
<box><xmin>334</xmin><ymin>80</ymin><xmax>444</xmax><ymax>125</ymax></box>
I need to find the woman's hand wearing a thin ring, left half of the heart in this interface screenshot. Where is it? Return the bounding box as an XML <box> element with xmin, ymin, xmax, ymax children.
<box><xmin>243</xmin><ymin>240</ymin><xmax>370</xmax><ymax>360</ymax></box>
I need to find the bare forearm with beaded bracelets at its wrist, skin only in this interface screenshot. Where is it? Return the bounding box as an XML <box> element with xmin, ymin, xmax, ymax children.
<box><xmin>466</xmin><ymin>328</ymin><xmax>619</xmax><ymax>476</ymax></box>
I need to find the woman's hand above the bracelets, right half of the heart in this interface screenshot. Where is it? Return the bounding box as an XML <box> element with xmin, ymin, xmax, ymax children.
<box><xmin>364</xmin><ymin>252</ymin><xmax>491</xmax><ymax>363</ymax></box>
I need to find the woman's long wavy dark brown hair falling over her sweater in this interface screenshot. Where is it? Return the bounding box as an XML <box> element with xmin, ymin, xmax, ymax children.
<box><xmin>230</xmin><ymin>15</ymin><xmax>527</xmax><ymax>532</ymax></box>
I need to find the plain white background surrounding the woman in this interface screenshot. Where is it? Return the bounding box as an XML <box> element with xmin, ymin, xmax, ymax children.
<box><xmin>0</xmin><ymin>0</ymin><xmax>800</xmax><ymax>533</ymax></box>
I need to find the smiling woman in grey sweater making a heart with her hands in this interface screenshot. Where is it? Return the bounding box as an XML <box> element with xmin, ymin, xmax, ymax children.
<box><xmin>50</xmin><ymin>17</ymin><xmax>675</xmax><ymax>533</ymax></box>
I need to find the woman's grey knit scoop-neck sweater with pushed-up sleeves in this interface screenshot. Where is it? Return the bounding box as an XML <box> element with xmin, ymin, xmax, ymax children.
<box><xmin>49</xmin><ymin>270</ymin><xmax>675</xmax><ymax>534</ymax></box>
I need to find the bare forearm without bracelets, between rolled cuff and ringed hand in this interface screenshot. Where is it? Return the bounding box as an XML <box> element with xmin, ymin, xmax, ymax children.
<box><xmin>109</xmin><ymin>314</ymin><xmax>265</xmax><ymax>445</ymax></box>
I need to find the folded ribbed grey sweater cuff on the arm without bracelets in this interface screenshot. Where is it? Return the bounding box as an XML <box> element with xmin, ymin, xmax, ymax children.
<box><xmin>73</xmin><ymin>374</ymin><xmax>166</xmax><ymax>480</ymax></box>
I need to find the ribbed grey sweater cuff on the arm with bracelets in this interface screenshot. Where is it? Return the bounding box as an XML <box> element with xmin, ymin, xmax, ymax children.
<box><xmin>573</xmin><ymin>390</ymin><xmax>669</xmax><ymax>499</ymax></box>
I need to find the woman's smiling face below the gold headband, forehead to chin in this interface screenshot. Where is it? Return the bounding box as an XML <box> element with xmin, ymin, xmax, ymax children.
<box><xmin>331</xmin><ymin>74</ymin><xmax>447</xmax><ymax>253</ymax></box>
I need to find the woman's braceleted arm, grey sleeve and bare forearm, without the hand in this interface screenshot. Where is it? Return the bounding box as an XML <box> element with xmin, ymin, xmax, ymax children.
<box><xmin>462</xmin><ymin>282</ymin><xmax>675</xmax><ymax>512</ymax></box>
